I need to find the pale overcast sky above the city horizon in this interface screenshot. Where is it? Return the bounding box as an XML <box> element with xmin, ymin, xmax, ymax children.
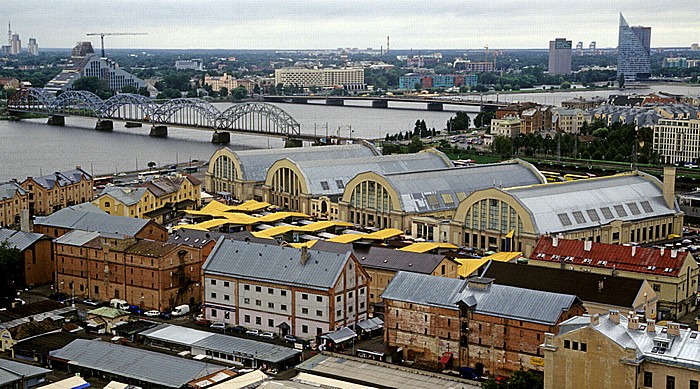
<box><xmin>3</xmin><ymin>0</ymin><xmax>700</xmax><ymax>49</ymax></box>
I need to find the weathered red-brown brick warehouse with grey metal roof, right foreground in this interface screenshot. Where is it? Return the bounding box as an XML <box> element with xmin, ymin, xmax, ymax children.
<box><xmin>382</xmin><ymin>272</ymin><xmax>584</xmax><ymax>375</ymax></box>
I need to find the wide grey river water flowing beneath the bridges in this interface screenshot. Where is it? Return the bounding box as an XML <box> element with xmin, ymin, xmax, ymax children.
<box><xmin>0</xmin><ymin>85</ymin><xmax>700</xmax><ymax>182</ymax></box>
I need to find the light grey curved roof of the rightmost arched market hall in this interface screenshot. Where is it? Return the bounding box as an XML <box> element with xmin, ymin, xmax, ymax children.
<box><xmin>505</xmin><ymin>172</ymin><xmax>680</xmax><ymax>234</ymax></box>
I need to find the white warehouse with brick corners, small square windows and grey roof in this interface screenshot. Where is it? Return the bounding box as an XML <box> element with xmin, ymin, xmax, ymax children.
<box><xmin>203</xmin><ymin>239</ymin><xmax>370</xmax><ymax>338</ymax></box>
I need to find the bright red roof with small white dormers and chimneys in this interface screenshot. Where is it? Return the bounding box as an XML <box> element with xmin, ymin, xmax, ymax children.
<box><xmin>530</xmin><ymin>236</ymin><xmax>694</xmax><ymax>277</ymax></box>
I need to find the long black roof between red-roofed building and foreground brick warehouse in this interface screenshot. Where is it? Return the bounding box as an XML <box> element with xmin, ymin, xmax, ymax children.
<box><xmin>482</xmin><ymin>261</ymin><xmax>651</xmax><ymax>308</ymax></box>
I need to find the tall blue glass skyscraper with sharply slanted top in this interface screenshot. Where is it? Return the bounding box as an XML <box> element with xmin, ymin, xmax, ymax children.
<box><xmin>617</xmin><ymin>14</ymin><xmax>651</xmax><ymax>81</ymax></box>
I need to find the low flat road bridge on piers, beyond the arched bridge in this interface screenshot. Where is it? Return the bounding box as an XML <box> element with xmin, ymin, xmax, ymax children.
<box><xmin>263</xmin><ymin>96</ymin><xmax>508</xmax><ymax>111</ymax></box>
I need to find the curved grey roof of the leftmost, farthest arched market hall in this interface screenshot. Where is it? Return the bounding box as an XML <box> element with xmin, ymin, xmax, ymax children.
<box><xmin>229</xmin><ymin>143</ymin><xmax>379</xmax><ymax>181</ymax></box>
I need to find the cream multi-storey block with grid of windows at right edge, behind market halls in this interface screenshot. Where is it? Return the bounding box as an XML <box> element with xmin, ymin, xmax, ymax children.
<box><xmin>654</xmin><ymin>118</ymin><xmax>700</xmax><ymax>163</ymax></box>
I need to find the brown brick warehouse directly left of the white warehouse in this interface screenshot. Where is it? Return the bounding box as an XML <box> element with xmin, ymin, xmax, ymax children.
<box><xmin>54</xmin><ymin>230</ymin><xmax>202</xmax><ymax>311</ymax></box>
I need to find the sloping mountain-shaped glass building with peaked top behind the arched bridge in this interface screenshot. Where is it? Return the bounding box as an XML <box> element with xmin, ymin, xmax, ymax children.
<box><xmin>44</xmin><ymin>42</ymin><xmax>146</xmax><ymax>93</ymax></box>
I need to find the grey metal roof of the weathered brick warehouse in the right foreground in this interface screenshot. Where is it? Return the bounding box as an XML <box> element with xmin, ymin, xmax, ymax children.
<box><xmin>382</xmin><ymin>271</ymin><xmax>579</xmax><ymax>325</ymax></box>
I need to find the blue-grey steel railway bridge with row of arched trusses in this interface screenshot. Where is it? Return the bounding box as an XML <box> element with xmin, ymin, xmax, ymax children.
<box><xmin>7</xmin><ymin>88</ymin><xmax>321</xmax><ymax>144</ymax></box>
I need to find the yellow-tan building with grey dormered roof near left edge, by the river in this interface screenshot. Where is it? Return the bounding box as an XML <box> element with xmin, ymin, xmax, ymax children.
<box><xmin>20</xmin><ymin>167</ymin><xmax>95</xmax><ymax>216</ymax></box>
